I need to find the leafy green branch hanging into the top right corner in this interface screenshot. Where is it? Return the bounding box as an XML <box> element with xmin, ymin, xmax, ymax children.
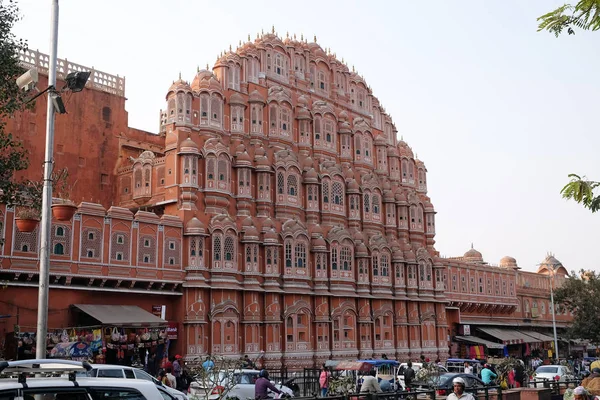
<box><xmin>537</xmin><ymin>0</ymin><xmax>600</xmax><ymax>37</ymax></box>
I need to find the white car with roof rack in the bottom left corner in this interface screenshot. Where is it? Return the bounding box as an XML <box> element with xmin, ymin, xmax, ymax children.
<box><xmin>0</xmin><ymin>360</ymin><xmax>164</xmax><ymax>400</ymax></box>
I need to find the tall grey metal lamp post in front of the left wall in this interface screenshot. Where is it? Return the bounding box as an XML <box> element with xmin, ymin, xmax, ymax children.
<box><xmin>35</xmin><ymin>0</ymin><xmax>58</xmax><ymax>359</ymax></box>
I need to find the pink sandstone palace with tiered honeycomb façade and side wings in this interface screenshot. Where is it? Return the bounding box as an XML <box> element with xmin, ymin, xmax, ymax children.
<box><xmin>0</xmin><ymin>33</ymin><xmax>572</xmax><ymax>368</ymax></box>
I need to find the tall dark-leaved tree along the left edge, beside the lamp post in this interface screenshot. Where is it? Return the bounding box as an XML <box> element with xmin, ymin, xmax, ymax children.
<box><xmin>0</xmin><ymin>0</ymin><xmax>29</xmax><ymax>212</ymax></box>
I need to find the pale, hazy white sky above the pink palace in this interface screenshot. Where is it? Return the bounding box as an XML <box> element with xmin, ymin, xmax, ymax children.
<box><xmin>10</xmin><ymin>0</ymin><xmax>600</xmax><ymax>271</ymax></box>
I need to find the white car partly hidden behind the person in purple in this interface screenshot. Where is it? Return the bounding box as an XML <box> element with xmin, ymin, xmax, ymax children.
<box><xmin>190</xmin><ymin>369</ymin><xmax>294</xmax><ymax>400</ymax></box>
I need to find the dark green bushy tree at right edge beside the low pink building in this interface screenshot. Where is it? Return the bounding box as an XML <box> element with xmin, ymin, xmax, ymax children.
<box><xmin>554</xmin><ymin>270</ymin><xmax>600</xmax><ymax>345</ymax></box>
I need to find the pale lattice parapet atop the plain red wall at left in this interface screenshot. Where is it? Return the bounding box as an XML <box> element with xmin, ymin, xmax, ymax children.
<box><xmin>19</xmin><ymin>49</ymin><xmax>125</xmax><ymax>97</ymax></box>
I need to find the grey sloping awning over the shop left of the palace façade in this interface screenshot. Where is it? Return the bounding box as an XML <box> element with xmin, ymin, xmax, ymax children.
<box><xmin>73</xmin><ymin>304</ymin><xmax>168</xmax><ymax>327</ymax></box>
